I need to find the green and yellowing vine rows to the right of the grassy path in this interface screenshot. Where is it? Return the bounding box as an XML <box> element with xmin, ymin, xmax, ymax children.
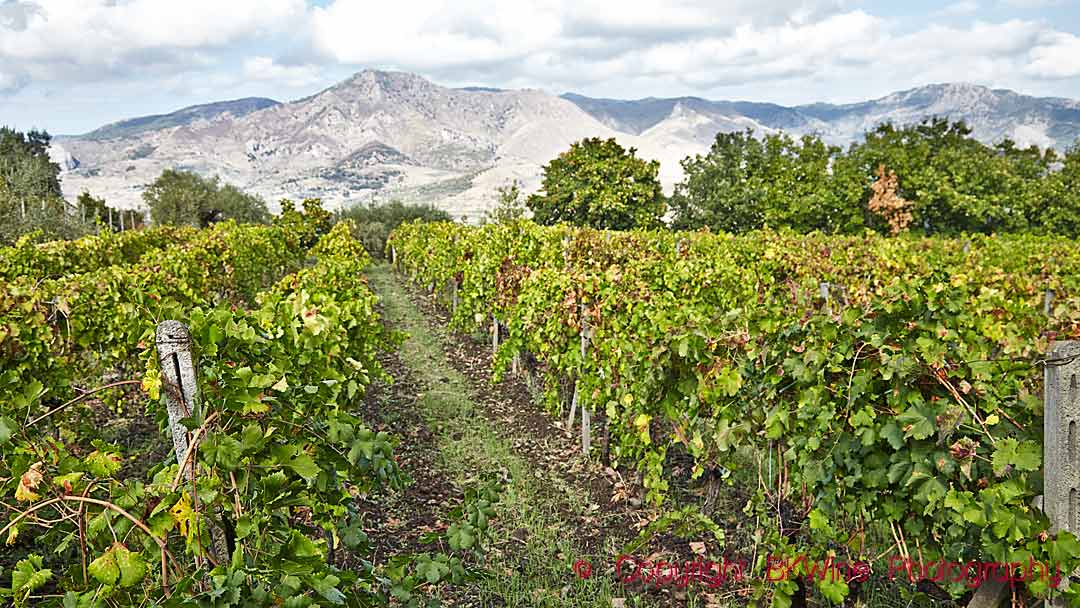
<box><xmin>389</xmin><ymin>222</ymin><xmax>1080</xmax><ymax>606</ymax></box>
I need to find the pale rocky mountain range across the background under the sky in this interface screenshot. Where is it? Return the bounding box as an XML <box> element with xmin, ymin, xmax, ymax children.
<box><xmin>51</xmin><ymin>70</ymin><xmax>1080</xmax><ymax>219</ymax></box>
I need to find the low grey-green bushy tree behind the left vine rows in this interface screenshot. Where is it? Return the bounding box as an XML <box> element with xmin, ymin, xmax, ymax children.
<box><xmin>143</xmin><ymin>168</ymin><xmax>270</xmax><ymax>227</ymax></box>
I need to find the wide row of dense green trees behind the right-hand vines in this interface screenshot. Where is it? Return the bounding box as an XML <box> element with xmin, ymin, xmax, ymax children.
<box><xmin>672</xmin><ymin>119</ymin><xmax>1080</xmax><ymax>235</ymax></box>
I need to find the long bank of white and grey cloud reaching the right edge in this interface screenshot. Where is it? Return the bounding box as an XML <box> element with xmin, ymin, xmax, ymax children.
<box><xmin>310</xmin><ymin>0</ymin><xmax>1080</xmax><ymax>102</ymax></box>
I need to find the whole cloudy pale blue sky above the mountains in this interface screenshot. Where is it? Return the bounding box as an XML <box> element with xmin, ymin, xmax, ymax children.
<box><xmin>0</xmin><ymin>0</ymin><xmax>1080</xmax><ymax>134</ymax></box>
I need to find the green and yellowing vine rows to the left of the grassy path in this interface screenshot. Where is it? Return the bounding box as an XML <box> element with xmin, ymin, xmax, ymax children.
<box><xmin>0</xmin><ymin>208</ymin><xmax>494</xmax><ymax>607</ymax></box>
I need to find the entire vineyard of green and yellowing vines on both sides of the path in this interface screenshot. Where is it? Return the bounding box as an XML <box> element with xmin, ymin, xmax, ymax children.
<box><xmin>6</xmin><ymin>212</ymin><xmax>1080</xmax><ymax>608</ymax></box>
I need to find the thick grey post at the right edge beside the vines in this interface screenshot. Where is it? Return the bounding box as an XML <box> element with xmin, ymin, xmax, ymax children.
<box><xmin>1042</xmin><ymin>341</ymin><xmax>1080</xmax><ymax>607</ymax></box>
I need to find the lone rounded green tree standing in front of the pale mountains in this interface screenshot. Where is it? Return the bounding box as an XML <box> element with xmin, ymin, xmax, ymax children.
<box><xmin>526</xmin><ymin>137</ymin><xmax>665</xmax><ymax>230</ymax></box>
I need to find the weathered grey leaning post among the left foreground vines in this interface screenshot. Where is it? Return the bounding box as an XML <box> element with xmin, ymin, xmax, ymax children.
<box><xmin>156</xmin><ymin>321</ymin><xmax>229</xmax><ymax>563</ymax></box>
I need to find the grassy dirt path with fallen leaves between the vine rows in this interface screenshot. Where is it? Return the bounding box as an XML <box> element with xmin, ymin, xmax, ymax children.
<box><xmin>365</xmin><ymin>267</ymin><xmax>730</xmax><ymax>606</ymax></box>
